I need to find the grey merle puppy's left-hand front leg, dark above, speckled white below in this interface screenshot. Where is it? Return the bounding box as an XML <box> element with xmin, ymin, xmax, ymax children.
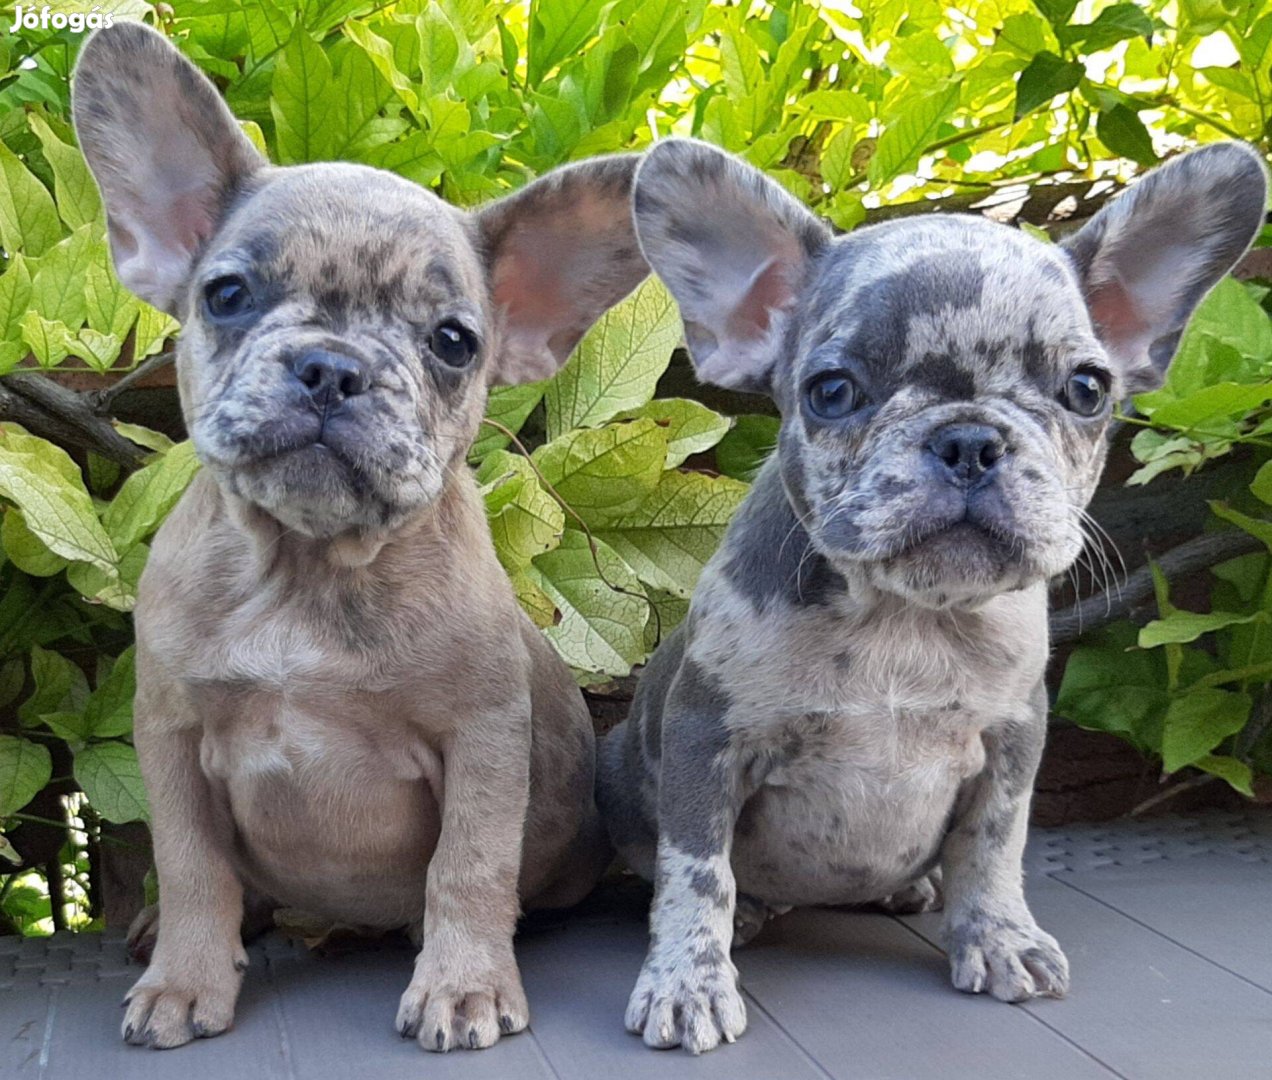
<box><xmin>626</xmin><ymin>660</ymin><xmax>747</xmax><ymax>1053</ymax></box>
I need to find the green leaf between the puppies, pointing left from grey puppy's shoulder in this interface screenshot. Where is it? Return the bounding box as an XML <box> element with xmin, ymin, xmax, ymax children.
<box><xmin>593</xmin><ymin>472</ymin><xmax>747</xmax><ymax>599</ymax></box>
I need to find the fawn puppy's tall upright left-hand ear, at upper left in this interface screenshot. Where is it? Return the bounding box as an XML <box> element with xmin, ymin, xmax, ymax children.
<box><xmin>73</xmin><ymin>22</ymin><xmax>265</xmax><ymax>314</ymax></box>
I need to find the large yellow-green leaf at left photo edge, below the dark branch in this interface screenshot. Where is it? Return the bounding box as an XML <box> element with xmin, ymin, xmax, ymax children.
<box><xmin>0</xmin><ymin>425</ymin><xmax>118</xmax><ymax>576</ymax></box>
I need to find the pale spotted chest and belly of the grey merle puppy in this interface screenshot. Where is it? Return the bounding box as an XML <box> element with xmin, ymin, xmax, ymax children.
<box><xmin>689</xmin><ymin>572</ymin><xmax>1046</xmax><ymax>906</ymax></box>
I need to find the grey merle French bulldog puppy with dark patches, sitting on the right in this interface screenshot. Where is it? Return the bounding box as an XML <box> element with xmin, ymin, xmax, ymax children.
<box><xmin>598</xmin><ymin>140</ymin><xmax>1266</xmax><ymax>1053</ymax></box>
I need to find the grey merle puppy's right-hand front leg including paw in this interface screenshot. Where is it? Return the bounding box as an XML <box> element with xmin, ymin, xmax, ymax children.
<box><xmin>941</xmin><ymin>691</ymin><xmax>1068</xmax><ymax>1001</ymax></box>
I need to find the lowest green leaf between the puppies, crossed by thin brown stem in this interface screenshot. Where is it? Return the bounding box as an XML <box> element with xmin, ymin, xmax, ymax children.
<box><xmin>525</xmin><ymin>529</ymin><xmax>649</xmax><ymax>675</ymax></box>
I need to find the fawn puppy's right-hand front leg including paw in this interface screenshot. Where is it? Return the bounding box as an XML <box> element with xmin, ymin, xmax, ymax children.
<box><xmin>397</xmin><ymin>700</ymin><xmax>530</xmax><ymax>1051</ymax></box>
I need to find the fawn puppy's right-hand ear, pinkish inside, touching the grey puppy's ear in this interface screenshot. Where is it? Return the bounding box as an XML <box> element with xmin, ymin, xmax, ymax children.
<box><xmin>477</xmin><ymin>155</ymin><xmax>649</xmax><ymax>385</ymax></box>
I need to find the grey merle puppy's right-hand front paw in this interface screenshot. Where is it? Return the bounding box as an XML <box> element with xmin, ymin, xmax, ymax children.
<box><xmin>946</xmin><ymin>917</ymin><xmax>1068</xmax><ymax>1001</ymax></box>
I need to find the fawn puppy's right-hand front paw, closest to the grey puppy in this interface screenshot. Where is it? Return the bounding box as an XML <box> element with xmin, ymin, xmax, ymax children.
<box><xmin>397</xmin><ymin>958</ymin><xmax>530</xmax><ymax>1052</ymax></box>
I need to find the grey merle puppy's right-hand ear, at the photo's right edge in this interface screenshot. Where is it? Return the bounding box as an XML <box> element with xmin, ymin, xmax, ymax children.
<box><xmin>1065</xmin><ymin>142</ymin><xmax>1267</xmax><ymax>393</ymax></box>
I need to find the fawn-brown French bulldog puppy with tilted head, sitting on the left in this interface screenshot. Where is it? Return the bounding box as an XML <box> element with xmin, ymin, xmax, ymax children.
<box><xmin>74</xmin><ymin>23</ymin><xmax>647</xmax><ymax>1051</ymax></box>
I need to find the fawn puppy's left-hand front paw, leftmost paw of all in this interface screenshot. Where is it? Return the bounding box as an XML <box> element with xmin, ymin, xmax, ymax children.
<box><xmin>122</xmin><ymin>948</ymin><xmax>247</xmax><ymax>1049</ymax></box>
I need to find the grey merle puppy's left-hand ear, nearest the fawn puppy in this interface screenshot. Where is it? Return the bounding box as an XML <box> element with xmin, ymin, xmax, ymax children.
<box><xmin>632</xmin><ymin>139</ymin><xmax>831</xmax><ymax>393</ymax></box>
